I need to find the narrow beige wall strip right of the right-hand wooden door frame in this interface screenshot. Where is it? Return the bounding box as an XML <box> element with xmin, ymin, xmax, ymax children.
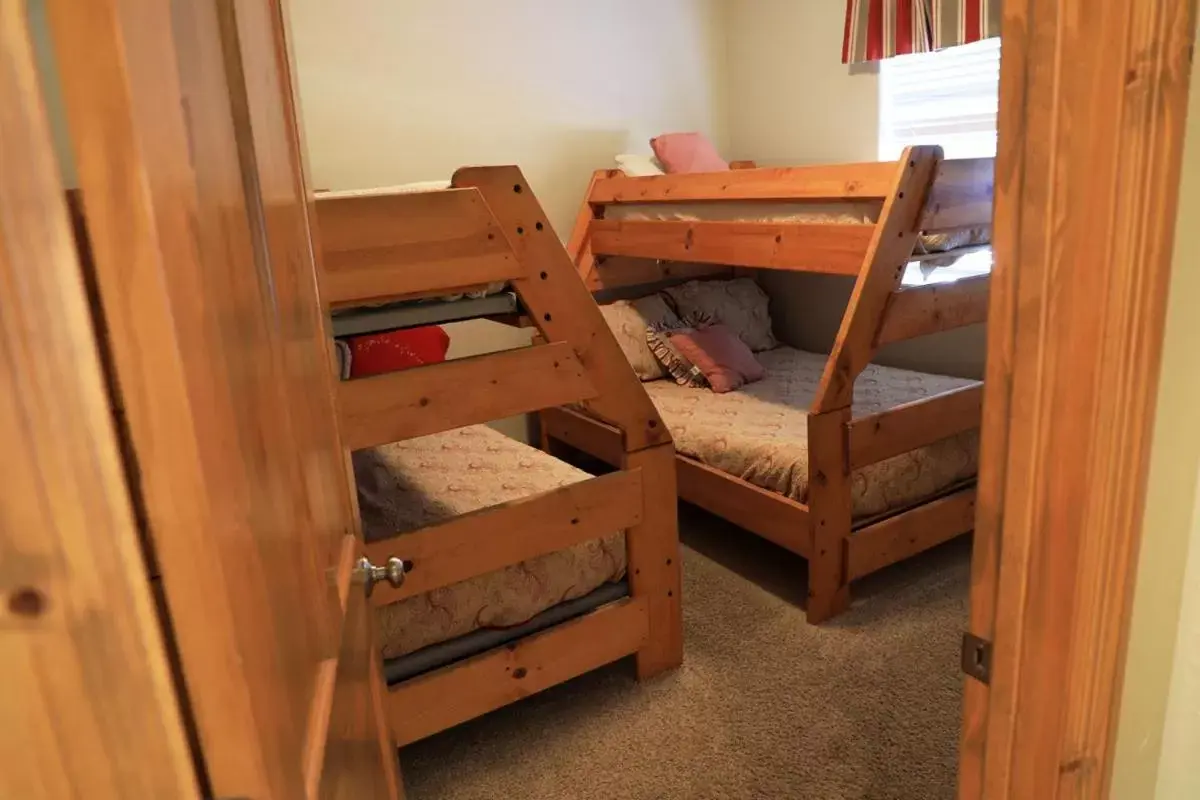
<box><xmin>1112</xmin><ymin>21</ymin><xmax>1200</xmax><ymax>800</ymax></box>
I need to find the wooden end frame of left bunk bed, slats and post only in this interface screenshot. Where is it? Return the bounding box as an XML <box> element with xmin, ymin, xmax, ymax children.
<box><xmin>316</xmin><ymin>167</ymin><xmax>683</xmax><ymax>745</ymax></box>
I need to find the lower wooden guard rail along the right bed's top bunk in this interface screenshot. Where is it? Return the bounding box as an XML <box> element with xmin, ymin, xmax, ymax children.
<box><xmin>590</xmin><ymin>219</ymin><xmax>875</xmax><ymax>275</ymax></box>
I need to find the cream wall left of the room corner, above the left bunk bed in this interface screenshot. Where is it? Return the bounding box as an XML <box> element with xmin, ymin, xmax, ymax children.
<box><xmin>289</xmin><ymin>0</ymin><xmax>728</xmax><ymax>437</ymax></box>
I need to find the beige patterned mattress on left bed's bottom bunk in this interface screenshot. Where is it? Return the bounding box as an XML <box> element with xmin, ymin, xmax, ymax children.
<box><xmin>354</xmin><ymin>425</ymin><xmax>625</xmax><ymax>658</ymax></box>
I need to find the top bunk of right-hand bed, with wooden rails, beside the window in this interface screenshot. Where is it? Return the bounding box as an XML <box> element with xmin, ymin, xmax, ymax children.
<box><xmin>570</xmin><ymin>146</ymin><xmax>995</xmax><ymax>290</ymax></box>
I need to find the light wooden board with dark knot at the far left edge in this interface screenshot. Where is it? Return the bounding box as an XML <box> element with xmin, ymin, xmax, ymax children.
<box><xmin>0</xmin><ymin>2</ymin><xmax>199</xmax><ymax>800</ymax></box>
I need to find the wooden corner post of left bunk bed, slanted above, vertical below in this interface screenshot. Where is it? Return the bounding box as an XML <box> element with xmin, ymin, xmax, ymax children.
<box><xmin>454</xmin><ymin>167</ymin><xmax>683</xmax><ymax>678</ymax></box>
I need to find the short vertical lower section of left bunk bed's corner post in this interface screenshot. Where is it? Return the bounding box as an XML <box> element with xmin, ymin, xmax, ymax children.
<box><xmin>624</xmin><ymin>444</ymin><xmax>683</xmax><ymax>679</ymax></box>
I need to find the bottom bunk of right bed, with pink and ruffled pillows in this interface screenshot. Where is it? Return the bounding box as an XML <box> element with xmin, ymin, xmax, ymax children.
<box><xmin>541</xmin><ymin>278</ymin><xmax>983</xmax><ymax>621</ymax></box>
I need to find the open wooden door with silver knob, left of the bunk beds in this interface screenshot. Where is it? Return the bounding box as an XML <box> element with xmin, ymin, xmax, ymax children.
<box><xmin>49</xmin><ymin>0</ymin><xmax>400</xmax><ymax>800</ymax></box>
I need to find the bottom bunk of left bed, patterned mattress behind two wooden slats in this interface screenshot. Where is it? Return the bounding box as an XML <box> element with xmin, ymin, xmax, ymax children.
<box><xmin>352</xmin><ymin>425</ymin><xmax>682</xmax><ymax>746</ymax></box>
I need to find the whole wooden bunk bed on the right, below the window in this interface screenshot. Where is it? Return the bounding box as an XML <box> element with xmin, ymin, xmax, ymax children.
<box><xmin>540</xmin><ymin>146</ymin><xmax>994</xmax><ymax>624</ymax></box>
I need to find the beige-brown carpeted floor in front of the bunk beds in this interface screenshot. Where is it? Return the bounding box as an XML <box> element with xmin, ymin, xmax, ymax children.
<box><xmin>401</xmin><ymin>509</ymin><xmax>971</xmax><ymax>800</ymax></box>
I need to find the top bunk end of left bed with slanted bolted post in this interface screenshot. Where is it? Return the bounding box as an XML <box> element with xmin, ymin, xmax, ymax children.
<box><xmin>314</xmin><ymin>167</ymin><xmax>671</xmax><ymax>452</ymax></box>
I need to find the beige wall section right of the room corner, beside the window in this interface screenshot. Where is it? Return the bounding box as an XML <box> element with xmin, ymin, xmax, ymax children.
<box><xmin>728</xmin><ymin>0</ymin><xmax>985</xmax><ymax>378</ymax></box>
